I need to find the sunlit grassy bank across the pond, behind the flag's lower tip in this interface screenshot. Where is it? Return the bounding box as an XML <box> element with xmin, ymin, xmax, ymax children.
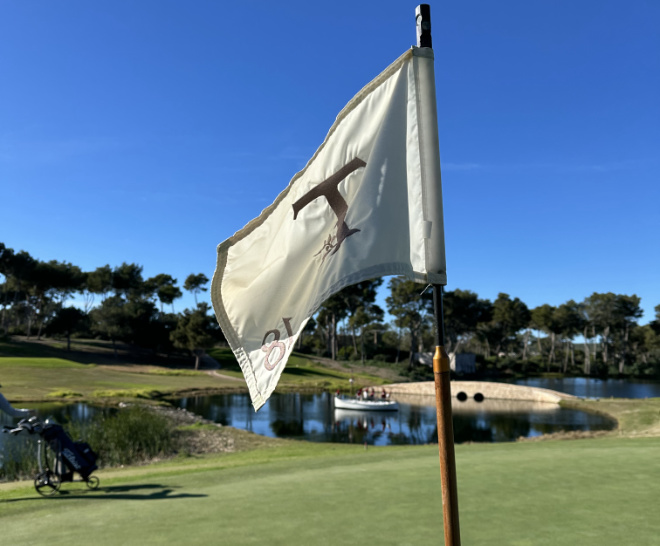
<box><xmin>0</xmin><ymin>334</ymin><xmax>392</xmax><ymax>403</ymax></box>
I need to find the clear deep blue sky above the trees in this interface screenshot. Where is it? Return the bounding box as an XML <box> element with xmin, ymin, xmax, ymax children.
<box><xmin>0</xmin><ymin>0</ymin><xmax>660</xmax><ymax>323</ymax></box>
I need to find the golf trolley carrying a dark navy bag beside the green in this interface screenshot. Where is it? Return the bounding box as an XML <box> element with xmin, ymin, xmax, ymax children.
<box><xmin>0</xmin><ymin>388</ymin><xmax>100</xmax><ymax>497</ymax></box>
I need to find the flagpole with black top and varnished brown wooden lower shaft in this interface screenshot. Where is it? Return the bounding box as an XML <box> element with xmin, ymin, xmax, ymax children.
<box><xmin>415</xmin><ymin>4</ymin><xmax>461</xmax><ymax>546</ymax></box>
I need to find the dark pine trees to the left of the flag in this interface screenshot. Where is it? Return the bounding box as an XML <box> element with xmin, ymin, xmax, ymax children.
<box><xmin>0</xmin><ymin>243</ymin><xmax>223</xmax><ymax>368</ymax></box>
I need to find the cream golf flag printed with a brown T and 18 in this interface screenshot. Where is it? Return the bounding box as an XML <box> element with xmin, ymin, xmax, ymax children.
<box><xmin>211</xmin><ymin>48</ymin><xmax>446</xmax><ymax>409</ymax></box>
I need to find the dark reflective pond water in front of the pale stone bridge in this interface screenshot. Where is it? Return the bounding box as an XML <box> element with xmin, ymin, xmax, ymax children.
<box><xmin>177</xmin><ymin>393</ymin><xmax>614</xmax><ymax>445</ymax></box>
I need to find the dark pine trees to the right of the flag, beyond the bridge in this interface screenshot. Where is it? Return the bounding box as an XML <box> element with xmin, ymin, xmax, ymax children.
<box><xmin>306</xmin><ymin>278</ymin><xmax>660</xmax><ymax>376</ymax></box>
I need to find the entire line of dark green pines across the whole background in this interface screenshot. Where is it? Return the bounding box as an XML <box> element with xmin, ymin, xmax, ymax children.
<box><xmin>0</xmin><ymin>243</ymin><xmax>660</xmax><ymax>375</ymax></box>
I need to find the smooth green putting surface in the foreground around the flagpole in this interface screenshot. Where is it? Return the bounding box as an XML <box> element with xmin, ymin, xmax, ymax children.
<box><xmin>0</xmin><ymin>438</ymin><xmax>660</xmax><ymax>546</ymax></box>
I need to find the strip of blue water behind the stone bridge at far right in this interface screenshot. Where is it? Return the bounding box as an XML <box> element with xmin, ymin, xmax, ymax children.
<box><xmin>510</xmin><ymin>377</ymin><xmax>660</xmax><ymax>398</ymax></box>
